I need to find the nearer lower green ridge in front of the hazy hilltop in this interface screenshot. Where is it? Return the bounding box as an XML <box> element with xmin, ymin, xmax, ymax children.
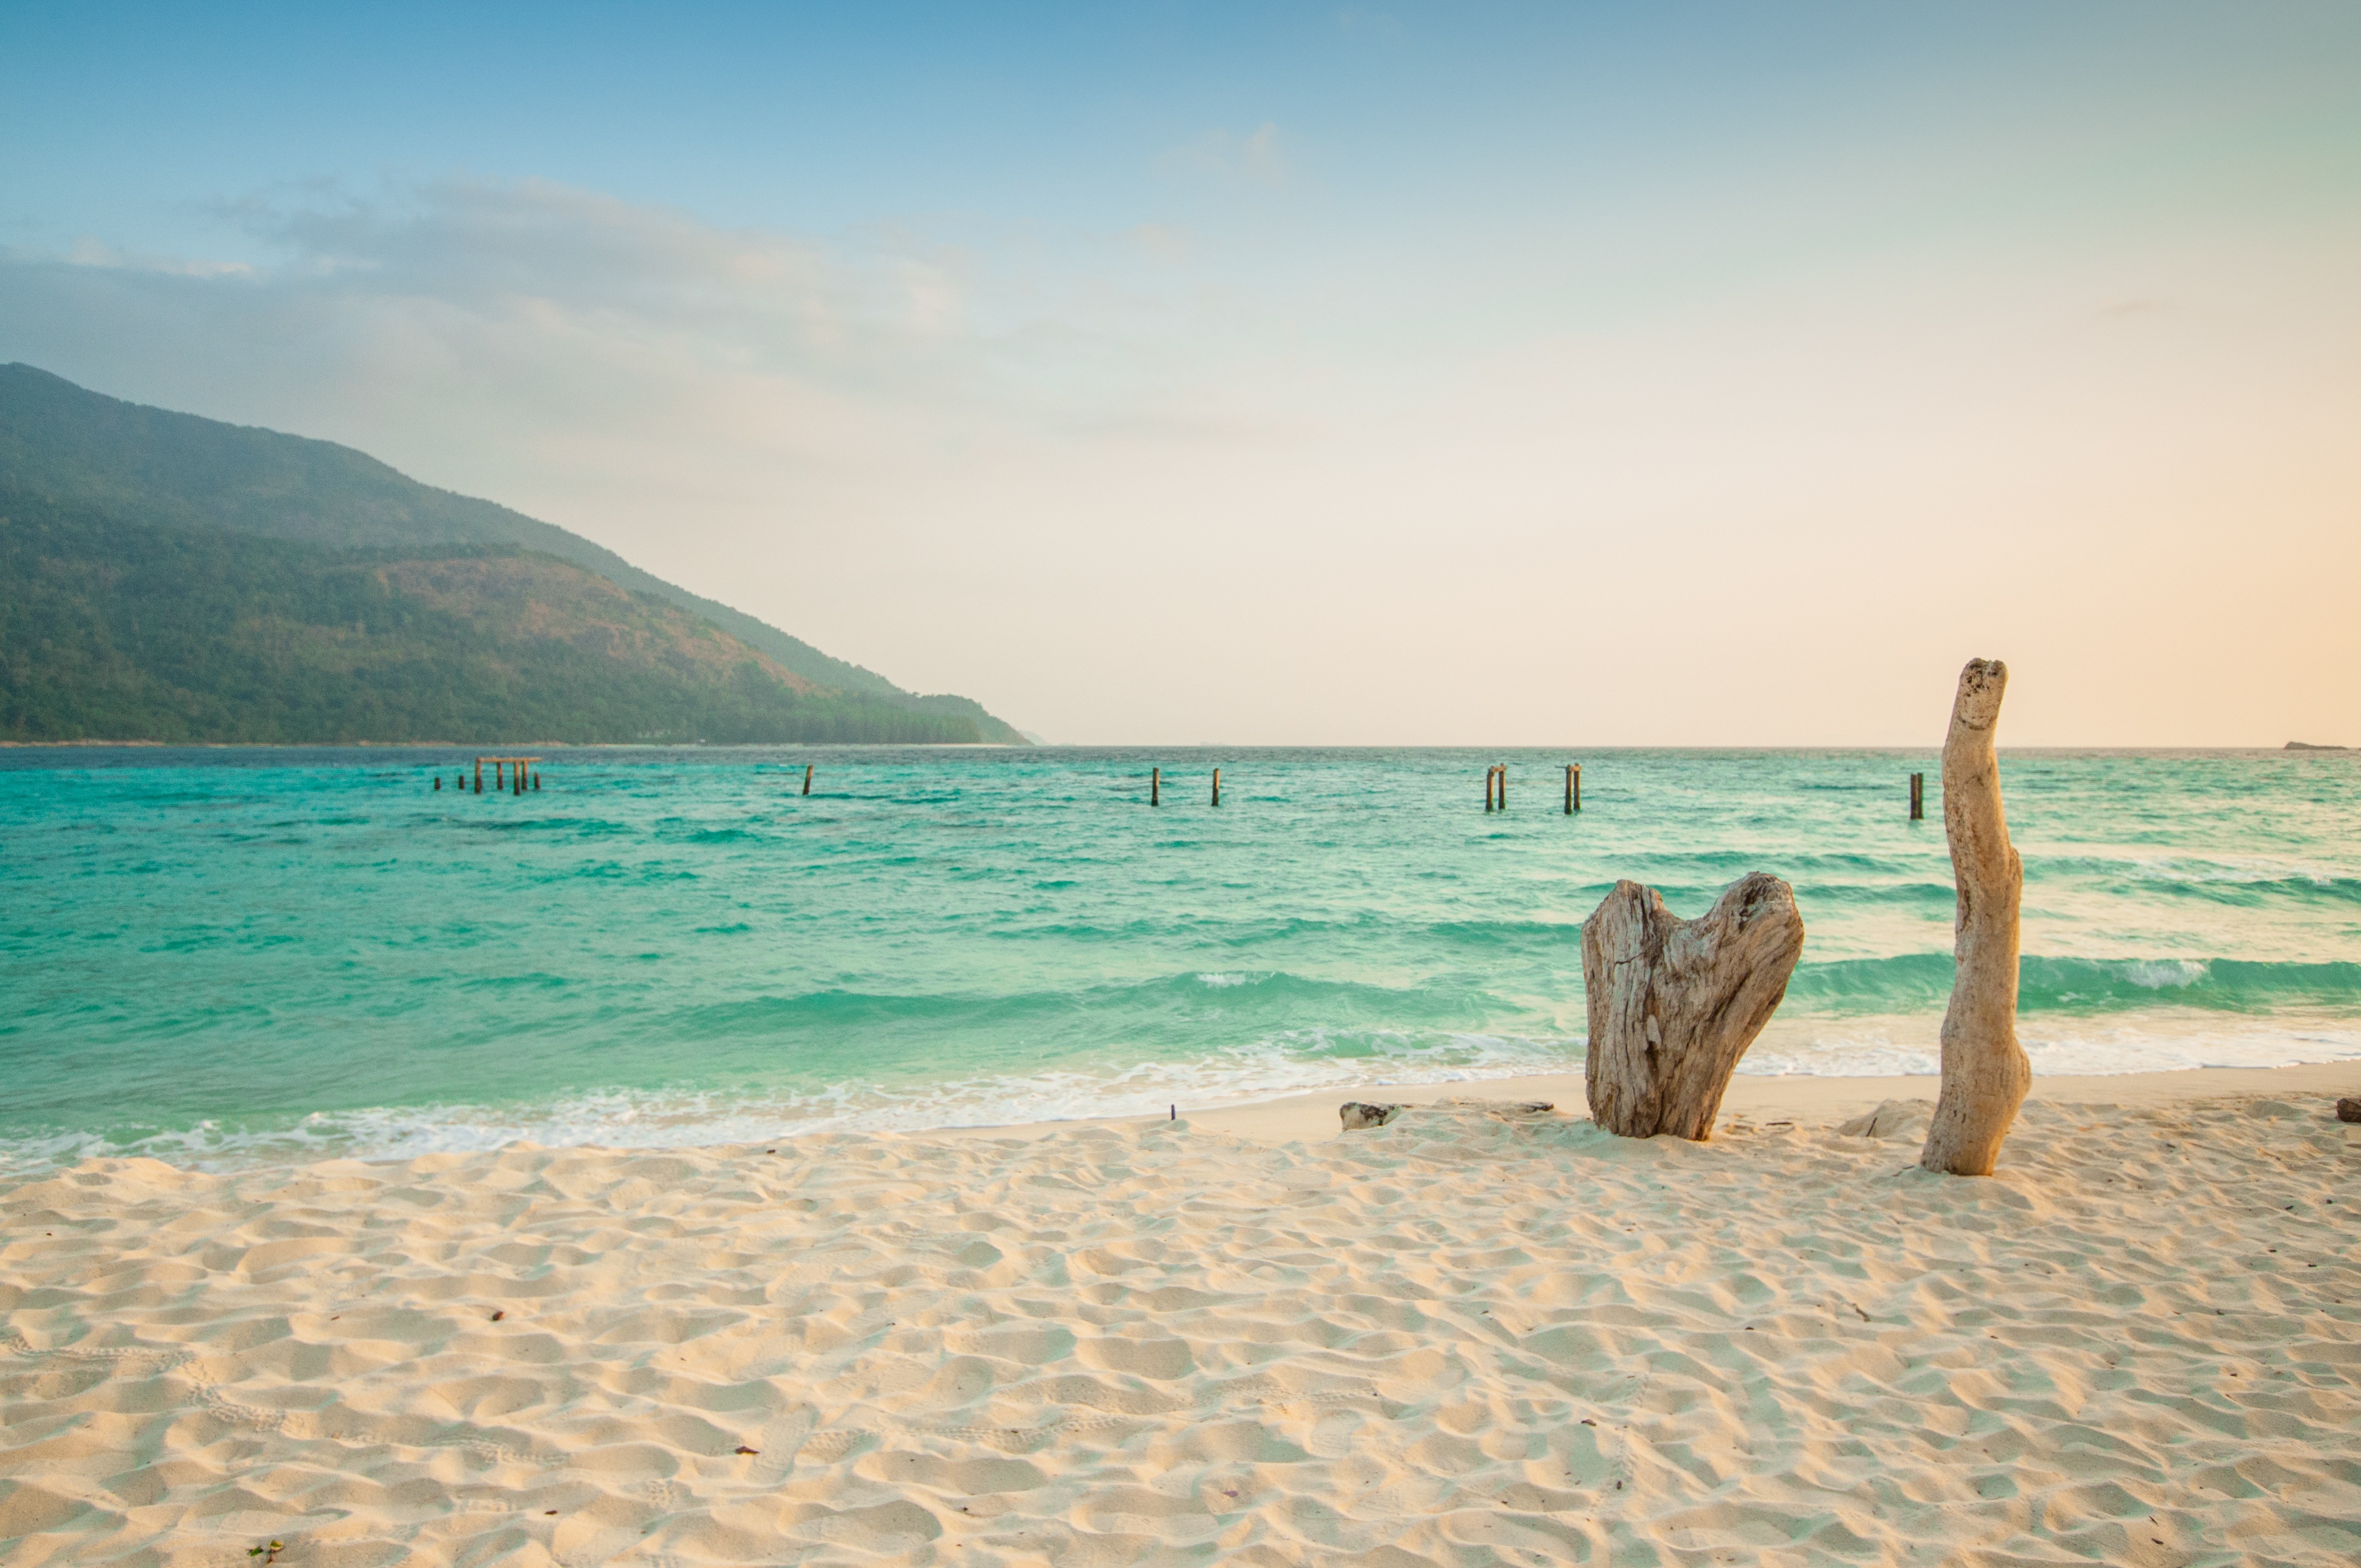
<box><xmin>0</xmin><ymin>498</ymin><xmax>996</xmax><ymax>744</ymax></box>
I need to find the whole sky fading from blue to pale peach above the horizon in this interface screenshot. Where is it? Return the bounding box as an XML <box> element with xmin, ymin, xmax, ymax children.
<box><xmin>0</xmin><ymin>0</ymin><xmax>2361</xmax><ymax>746</ymax></box>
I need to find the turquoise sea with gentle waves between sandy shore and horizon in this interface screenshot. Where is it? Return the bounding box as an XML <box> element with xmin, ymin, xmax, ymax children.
<box><xmin>0</xmin><ymin>746</ymin><xmax>2361</xmax><ymax>1164</ymax></box>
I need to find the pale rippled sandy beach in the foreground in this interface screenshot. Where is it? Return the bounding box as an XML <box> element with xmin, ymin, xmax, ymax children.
<box><xmin>0</xmin><ymin>1065</ymin><xmax>2361</xmax><ymax>1568</ymax></box>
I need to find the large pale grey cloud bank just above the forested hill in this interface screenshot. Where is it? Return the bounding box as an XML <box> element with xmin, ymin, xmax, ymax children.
<box><xmin>0</xmin><ymin>182</ymin><xmax>1076</xmax><ymax>472</ymax></box>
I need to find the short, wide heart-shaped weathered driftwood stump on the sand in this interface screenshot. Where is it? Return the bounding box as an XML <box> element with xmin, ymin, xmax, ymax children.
<box><xmin>1582</xmin><ymin>872</ymin><xmax>1804</xmax><ymax>1143</ymax></box>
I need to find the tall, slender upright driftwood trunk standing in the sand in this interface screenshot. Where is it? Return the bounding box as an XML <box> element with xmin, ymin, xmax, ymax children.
<box><xmin>1919</xmin><ymin>659</ymin><xmax>2033</xmax><ymax>1176</ymax></box>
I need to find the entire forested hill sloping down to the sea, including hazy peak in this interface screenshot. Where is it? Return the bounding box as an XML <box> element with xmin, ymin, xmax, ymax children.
<box><xmin>0</xmin><ymin>364</ymin><xmax>1020</xmax><ymax>742</ymax></box>
